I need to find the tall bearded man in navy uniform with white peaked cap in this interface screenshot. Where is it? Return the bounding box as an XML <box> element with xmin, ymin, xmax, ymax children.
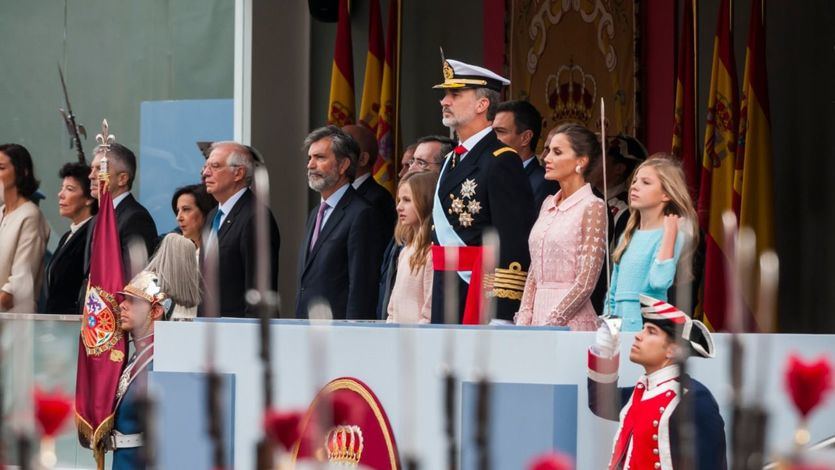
<box><xmin>432</xmin><ymin>60</ymin><xmax>534</xmax><ymax>324</ymax></box>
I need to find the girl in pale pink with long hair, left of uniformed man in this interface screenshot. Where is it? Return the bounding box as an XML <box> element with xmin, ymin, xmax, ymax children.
<box><xmin>387</xmin><ymin>172</ymin><xmax>438</xmax><ymax>323</ymax></box>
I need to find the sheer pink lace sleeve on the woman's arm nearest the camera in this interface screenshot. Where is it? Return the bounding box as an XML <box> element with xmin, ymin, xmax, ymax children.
<box><xmin>548</xmin><ymin>200</ymin><xmax>606</xmax><ymax>325</ymax></box>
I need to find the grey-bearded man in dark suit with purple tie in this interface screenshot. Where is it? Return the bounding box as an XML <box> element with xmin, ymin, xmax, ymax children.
<box><xmin>296</xmin><ymin>126</ymin><xmax>386</xmax><ymax>319</ymax></box>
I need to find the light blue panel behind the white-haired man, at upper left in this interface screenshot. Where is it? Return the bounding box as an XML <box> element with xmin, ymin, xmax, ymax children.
<box><xmin>138</xmin><ymin>100</ymin><xmax>234</xmax><ymax>234</ymax></box>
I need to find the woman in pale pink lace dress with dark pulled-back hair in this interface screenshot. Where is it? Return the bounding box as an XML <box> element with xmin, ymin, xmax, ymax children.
<box><xmin>516</xmin><ymin>124</ymin><xmax>606</xmax><ymax>331</ymax></box>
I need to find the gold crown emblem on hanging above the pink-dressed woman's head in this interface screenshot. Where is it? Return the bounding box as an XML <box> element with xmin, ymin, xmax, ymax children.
<box><xmin>545</xmin><ymin>64</ymin><xmax>597</xmax><ymax>125</ymax></box>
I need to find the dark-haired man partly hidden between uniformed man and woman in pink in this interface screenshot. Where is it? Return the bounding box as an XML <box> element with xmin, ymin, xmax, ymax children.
<box><xmin>493</xmin><ymin>100</ymin><xmax>559</xmax><ymax>208</ymax></box>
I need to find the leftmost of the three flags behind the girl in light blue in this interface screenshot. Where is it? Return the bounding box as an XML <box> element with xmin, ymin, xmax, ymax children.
<box><xmin>672</xmin><ymin>0</ymin><xmax>700</xmax><ymax>200</ymax></box>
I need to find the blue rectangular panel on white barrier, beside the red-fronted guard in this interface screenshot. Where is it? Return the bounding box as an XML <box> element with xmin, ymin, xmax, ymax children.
<box><xmin>460</xmin><ymin>382</ymin><xmax>577</xmax><ymax>470</ymax></box>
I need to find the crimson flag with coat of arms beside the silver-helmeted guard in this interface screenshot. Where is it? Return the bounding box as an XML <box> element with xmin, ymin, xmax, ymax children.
<box><xmin>75</xmin><ymin>170</ymin><xmax>127</xmax><ymax>469</ymax></box>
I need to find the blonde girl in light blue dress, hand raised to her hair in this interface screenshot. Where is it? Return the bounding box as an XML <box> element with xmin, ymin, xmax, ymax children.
<box><xmin>606</xmin><ymin>153</ymin><xmax>698</xmax><ymax>331</ymax></box>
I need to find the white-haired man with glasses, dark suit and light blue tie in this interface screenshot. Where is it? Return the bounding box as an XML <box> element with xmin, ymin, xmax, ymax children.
<box><xmin>200</xmin><ymin>141</ymin><xmax>281</xmax><ymax>317</ymax></box>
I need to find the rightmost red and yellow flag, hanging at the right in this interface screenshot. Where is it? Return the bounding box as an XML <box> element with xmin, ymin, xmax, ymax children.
<box><xmin>734</xmin><ymin>0</ymin><xmax>774</xmax><ymax>327</ymax></box>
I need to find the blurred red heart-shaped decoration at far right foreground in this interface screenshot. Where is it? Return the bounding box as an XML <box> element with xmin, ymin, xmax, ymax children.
<box><xmin>786</xmin><ymin>354</ymin><xmax>832</xmax><ymax>418</ymax></box>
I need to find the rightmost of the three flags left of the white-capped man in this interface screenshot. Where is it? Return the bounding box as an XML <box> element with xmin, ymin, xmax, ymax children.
<box><xmin>373</xmin><ymin>0</ymin><xmax>400</xmax><ymax>194</ymax></box>
